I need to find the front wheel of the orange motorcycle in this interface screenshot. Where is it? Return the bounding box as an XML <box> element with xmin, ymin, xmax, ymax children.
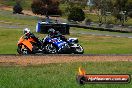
<box><xmin>17</xmin><ymin>45</ymin><xmax>30</xmax><ymax>55</ymax></box>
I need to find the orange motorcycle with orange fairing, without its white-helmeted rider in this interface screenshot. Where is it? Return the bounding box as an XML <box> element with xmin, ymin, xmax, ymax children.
<box><xmin>17</xmin><ymin>35</ymin><xmax>42</xmax><ymax>55</ymax></box>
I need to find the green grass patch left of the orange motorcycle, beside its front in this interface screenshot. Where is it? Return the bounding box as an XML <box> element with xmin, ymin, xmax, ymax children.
<box><xmin>0</xmin><ymin>29</ymin><xmax>22</xmax><ymax>54</ymax></box>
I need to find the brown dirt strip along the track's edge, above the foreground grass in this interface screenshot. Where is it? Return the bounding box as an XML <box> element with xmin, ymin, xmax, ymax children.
<box><xmin>0</xmin><ymin>55</ymin><xmax>132</xmax><ymax>66</ymax></box>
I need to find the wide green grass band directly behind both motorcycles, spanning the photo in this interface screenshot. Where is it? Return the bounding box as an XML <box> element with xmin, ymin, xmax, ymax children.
<box><xmin>0</xmin><ymin>28</ymin><xmax>132</xmax><ymax>54</ymax></box>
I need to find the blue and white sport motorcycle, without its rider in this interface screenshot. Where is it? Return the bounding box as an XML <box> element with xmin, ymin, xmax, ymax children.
<box><xmin>42</xmin><ymin>36</ymin><xmax>84</xmax><ymax>54</ymax></box>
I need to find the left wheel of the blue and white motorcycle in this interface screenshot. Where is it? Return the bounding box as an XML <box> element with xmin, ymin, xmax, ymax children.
<box><xmin>45</xmin><ymin>44</ymin><xmax>58</xmax><ymax>54</ymax></box>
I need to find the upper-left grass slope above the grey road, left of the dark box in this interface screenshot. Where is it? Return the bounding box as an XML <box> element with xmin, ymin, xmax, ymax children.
<box><xmin>0</xmin><ymin>10</ymin><xmax>39</xmax><ymax>26</ymax></box>
